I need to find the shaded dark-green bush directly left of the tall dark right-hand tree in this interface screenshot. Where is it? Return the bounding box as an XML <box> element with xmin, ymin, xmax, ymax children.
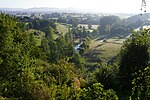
<box><xmin>94</xmin><ymin>64</ymin><xmax>119</xmax><ymax>90</ymax></box>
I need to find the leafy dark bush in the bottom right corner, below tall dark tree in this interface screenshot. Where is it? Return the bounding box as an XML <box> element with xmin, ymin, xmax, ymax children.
<box><xmin>130</xmin><ymin>66</ymin><xmax>150</xmax><ymax>100</ymax></box>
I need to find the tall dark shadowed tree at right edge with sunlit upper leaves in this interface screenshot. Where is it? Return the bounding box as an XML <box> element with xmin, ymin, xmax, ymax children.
<box><xmin>119</xmin><ymin>29</ymin><xmax>149</xmax><ymax>94</ymax></box>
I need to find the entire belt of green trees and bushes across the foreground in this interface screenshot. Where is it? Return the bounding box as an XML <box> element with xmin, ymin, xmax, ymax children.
<box><xmin>0</xmin><ymin>14</ymin><xmax>150</xmax><ymax>100</ymax></box>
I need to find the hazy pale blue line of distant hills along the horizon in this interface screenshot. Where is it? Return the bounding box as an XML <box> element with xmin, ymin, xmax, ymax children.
<box><xmin>0</xmin><ymin>7</ymin><xmax>135</xmax><ymax>18</ymax></box>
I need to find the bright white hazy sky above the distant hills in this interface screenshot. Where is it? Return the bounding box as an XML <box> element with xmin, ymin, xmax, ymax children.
<box><xmin>0</xmin><ymin>0</ymin><xmax>150</xmax><ymax>13</ymax></box>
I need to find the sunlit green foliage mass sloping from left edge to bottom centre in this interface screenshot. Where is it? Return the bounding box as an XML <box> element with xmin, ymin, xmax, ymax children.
<box><xmin>0</xmin><ymin>14</ymin><xmax>118</xmax><ymax>100</ymax></box>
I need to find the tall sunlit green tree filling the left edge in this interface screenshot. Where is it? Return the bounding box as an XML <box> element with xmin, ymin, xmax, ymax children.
<box><xmin>0</xmin><ymin>14</ymin><xmax>39</xmax><ymax>98</ymax></box>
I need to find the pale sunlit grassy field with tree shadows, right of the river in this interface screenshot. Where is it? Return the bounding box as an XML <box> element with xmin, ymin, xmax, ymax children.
<box><xmin>86</xmin><ymin>38</ymin><xmax>125</xmax><ymax>62</ymax></box>
